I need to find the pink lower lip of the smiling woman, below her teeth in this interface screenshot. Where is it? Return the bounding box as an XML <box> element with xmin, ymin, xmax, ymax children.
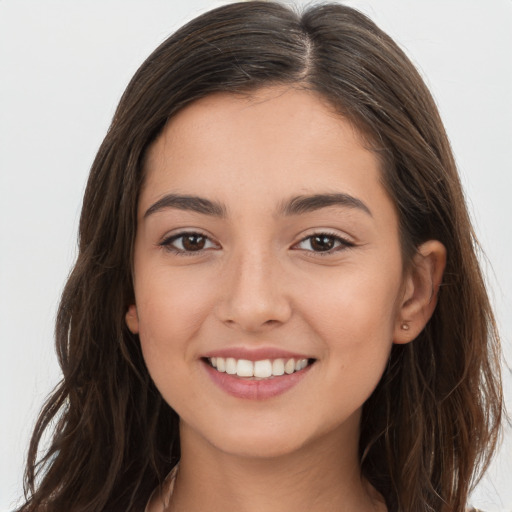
<box><xmin>203</xmin><ymin>361</ymin><xmax>313</xmax><ymax>400</ymax></box>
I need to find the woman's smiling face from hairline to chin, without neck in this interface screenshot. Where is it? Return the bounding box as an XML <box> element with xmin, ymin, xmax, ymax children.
<box><xmin>127</xmin><ymin>88</ymin><xmax>405</xmax><ymax>457</ymax></box>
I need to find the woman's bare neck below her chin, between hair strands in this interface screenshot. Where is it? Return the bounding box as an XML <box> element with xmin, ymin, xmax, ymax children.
<box><xmin>168</xmin><ymin>420</ymin><xmax>386</xmax><ymax>512</ymax></box>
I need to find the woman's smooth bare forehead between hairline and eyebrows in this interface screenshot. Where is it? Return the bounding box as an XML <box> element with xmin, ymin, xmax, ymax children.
<box><xmin>140</xmin><ymin>87</ymin><xmax>383</xmax><ymax>216</ymax></box>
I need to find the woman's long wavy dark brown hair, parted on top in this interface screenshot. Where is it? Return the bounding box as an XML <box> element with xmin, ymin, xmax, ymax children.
<box><xmin>20</xmin><ymin>1</ymin><xmax>503</xmax><ymax>512</ymax></box>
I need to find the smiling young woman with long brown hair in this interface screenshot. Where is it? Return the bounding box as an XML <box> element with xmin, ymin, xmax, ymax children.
<box><xmin>20</xmin><ymin>2</ymin><xmax>502</xmax><ymax>512</ymax></box>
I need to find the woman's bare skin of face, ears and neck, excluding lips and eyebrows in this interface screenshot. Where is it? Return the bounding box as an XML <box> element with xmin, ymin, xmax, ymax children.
<box><xmin>126</xmin><ymin>88</ymin><xmax>445</xmax><ymax>512</ymax></box>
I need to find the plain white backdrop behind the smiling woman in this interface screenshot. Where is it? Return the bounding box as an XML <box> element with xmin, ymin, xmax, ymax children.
<box><xmin>0</xmin><ymin>0</ymin><xmax>512</xmax><ymax>512</ymax></box>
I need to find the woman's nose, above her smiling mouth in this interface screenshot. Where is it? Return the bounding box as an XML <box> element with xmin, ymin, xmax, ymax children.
<box><xmin>217</xmin><ymin>250</ymin><xmax>292</xmax><ymax>333</ymax></box>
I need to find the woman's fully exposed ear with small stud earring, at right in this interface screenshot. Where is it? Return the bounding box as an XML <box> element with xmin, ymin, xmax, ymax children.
<box><xmin>393</xmin><ymin>240</ymin><xmax>446</xmax><ymax>344</ymax></box>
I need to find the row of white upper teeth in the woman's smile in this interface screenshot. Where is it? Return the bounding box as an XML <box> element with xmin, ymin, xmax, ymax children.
<box><xmin>209</xmin><ymin>357</ymin><xmax>308</xmax><ymax>379</ymax></box>
